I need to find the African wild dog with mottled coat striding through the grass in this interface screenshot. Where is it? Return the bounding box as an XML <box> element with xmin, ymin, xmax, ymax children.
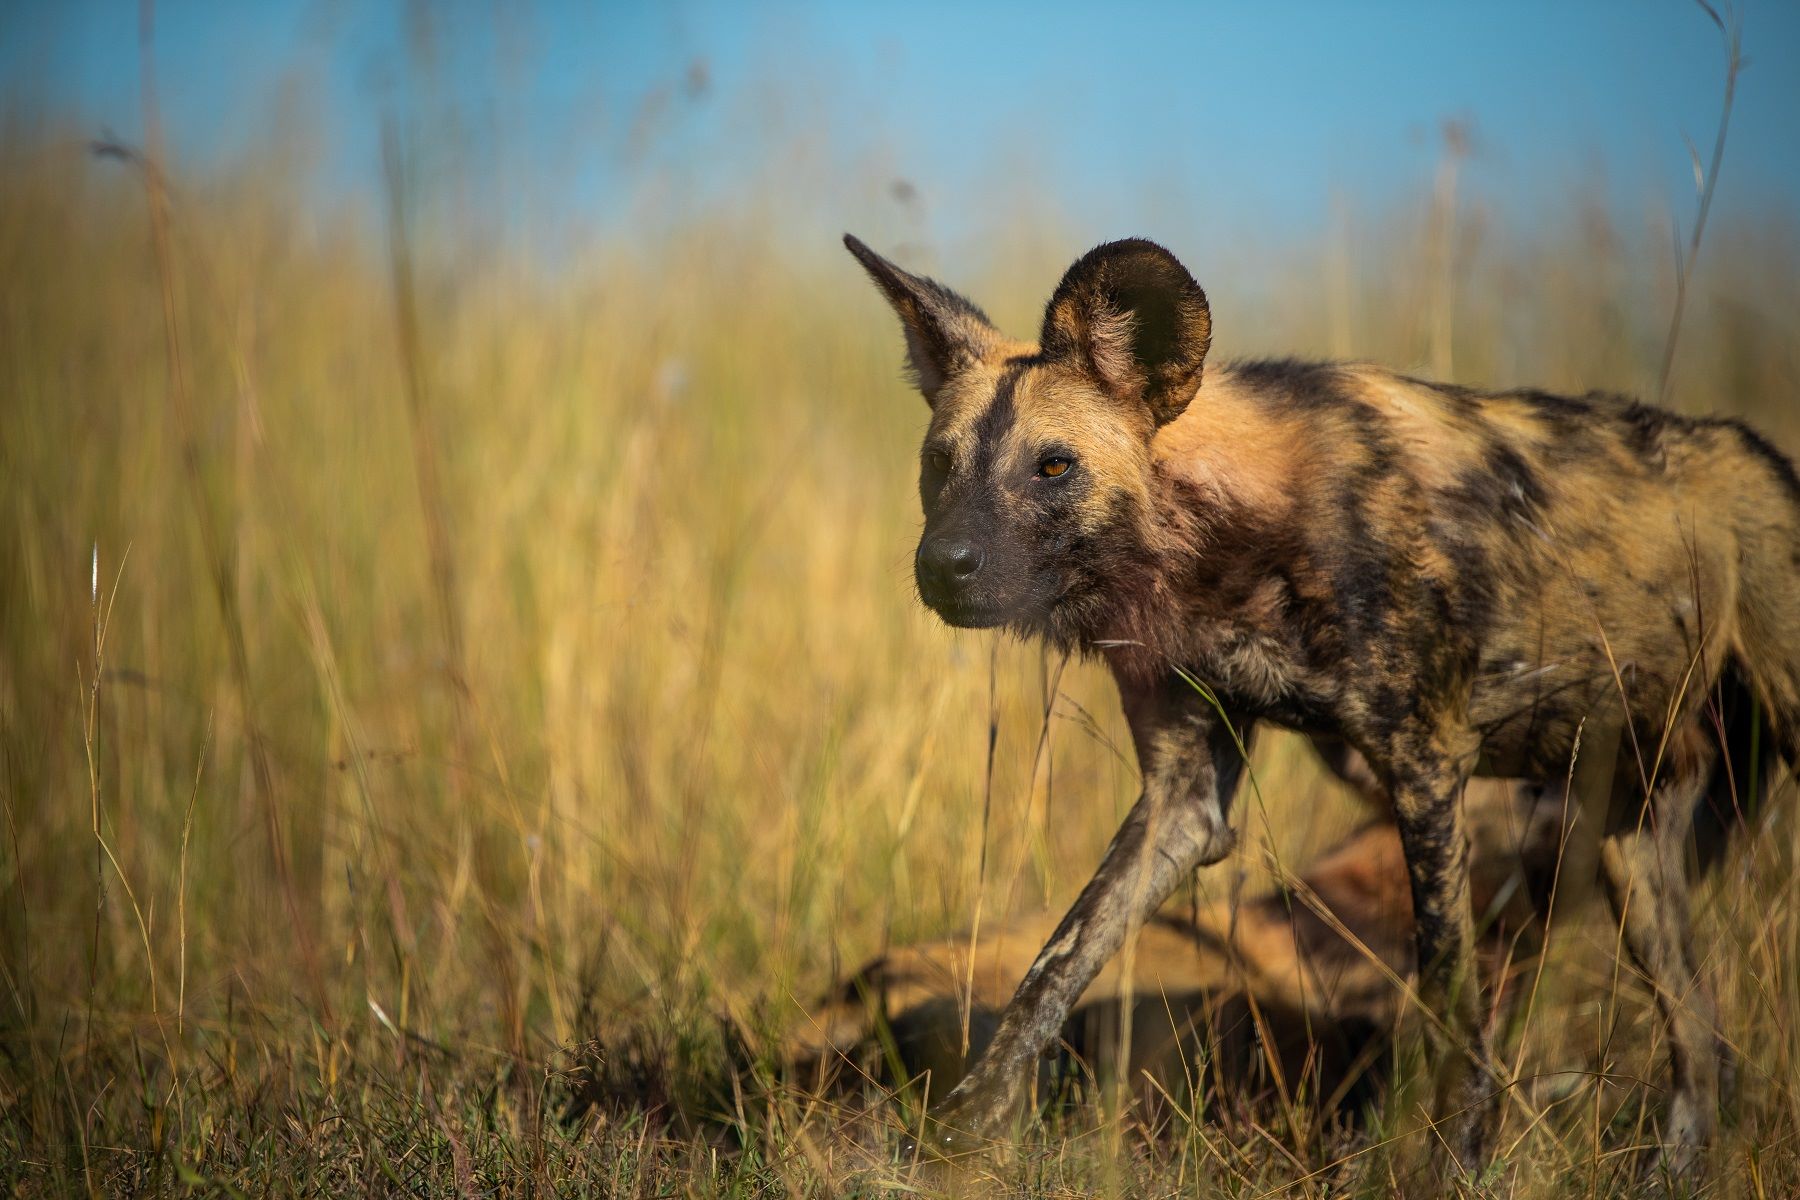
<box><xmin>846</xmin><ymin>237</ymin><xmax>1800</xmax><ymax>1168</ymax></box>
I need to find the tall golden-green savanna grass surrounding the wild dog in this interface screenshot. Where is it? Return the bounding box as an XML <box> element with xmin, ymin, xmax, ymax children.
<box><xmin>0</xmin><ymin>98</ymin><xmax>1800</xmax><ymax>1196</ymax></box>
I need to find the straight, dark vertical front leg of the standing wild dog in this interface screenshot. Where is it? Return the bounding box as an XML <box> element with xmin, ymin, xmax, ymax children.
<box><xmin>1384</xmin><ymin>721</ymin><xmax>1494</xmax><ymax>1169</ymax></box>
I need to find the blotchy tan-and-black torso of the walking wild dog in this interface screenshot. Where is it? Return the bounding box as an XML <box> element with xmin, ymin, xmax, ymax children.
<box><xmin>1152</xmin><ymin>360</ymin><xmax>1800</xmax><ymax>775</ymax></box>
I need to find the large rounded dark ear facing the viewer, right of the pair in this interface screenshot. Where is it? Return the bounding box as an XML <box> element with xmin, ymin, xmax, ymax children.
<box><xmin>1039</xmin><ymin>237</ymin><xmax>1213</xmax><ymax>426</ymax></box>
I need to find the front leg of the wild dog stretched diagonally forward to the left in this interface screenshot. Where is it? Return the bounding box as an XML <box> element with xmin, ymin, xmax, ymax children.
<box><xmin>907</xmin><ymin>689</ymin><xmax>1242</xmax><ymax>1153</ymax></box>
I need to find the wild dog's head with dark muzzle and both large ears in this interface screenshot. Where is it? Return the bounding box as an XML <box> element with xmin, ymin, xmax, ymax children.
<box><xmin>844</xmin><ymin>236</ymin><xmax>1211</xmax><ymax>644</ymax></box>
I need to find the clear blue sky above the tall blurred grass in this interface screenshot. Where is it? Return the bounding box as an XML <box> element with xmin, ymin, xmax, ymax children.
<box><xmin>0</xmin><ymin>0</ymin><xmax>1800</xmax><ymax>259</ymax></box>
